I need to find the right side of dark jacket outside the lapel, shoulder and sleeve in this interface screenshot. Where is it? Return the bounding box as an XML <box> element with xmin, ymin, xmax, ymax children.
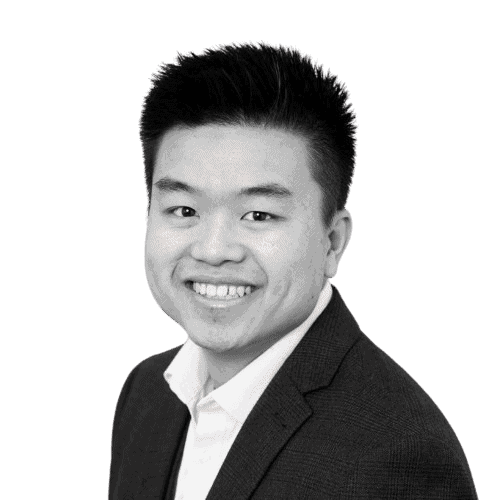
<box><xmin>262</xmin><ymin>334</ymin><xmax>477</xmax><ymax>500</ymax></box>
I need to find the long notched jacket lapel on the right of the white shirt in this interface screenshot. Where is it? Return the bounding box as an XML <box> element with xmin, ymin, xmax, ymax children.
<box><xmin>207</xmin><ymin>287</ymin><xmax>362</xmax><ymax>500</ymax></box>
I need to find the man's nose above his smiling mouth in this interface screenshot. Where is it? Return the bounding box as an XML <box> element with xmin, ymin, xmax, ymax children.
<box><xmin>191</xmin><ymin>214</ymin><xmax>245</xmax><ymax>266</ymax></box>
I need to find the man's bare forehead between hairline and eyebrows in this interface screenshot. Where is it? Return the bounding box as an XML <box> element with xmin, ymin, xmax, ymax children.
<box><xmin>153</xmin><ymin>125</ymin><xmax>317</xmax><ymax>195</ymax></box>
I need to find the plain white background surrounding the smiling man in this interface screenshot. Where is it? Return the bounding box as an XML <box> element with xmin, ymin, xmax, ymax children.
<box><xmin>4</xmin><ymin>2</ymin><xmax>500</xmax><ymax>499</ymax></box>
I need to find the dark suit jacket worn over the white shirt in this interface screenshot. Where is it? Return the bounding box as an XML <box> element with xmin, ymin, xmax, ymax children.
<box><xmin>109</xmin><ymin>287</ymin><xmax>478</xmax><ymax>500</ymax></box>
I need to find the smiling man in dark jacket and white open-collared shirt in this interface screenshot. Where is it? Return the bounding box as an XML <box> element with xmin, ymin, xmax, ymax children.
<box><xmin>109</xmin><ymin>44</ymin><xmax>477</xmax><ymax>500</ymax></box>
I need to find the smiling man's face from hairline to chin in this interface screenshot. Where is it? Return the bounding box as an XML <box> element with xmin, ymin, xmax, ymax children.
<box><xmin>145</xmin><ymin>126</ymin><xmax>344</xmax><ymax>355</ymax></box>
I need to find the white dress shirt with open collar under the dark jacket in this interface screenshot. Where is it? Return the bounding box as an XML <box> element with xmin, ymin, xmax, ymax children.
<box><xmin>164</xmin><ymin>280</ymin><xmax>332</xmax><ymax>500</ymax></box>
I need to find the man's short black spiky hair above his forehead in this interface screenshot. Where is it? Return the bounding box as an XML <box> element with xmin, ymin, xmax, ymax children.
<box><xmin>139</xmin><ymin>42</ymin><xmax>357</xmax><ymax>227</ymax></box>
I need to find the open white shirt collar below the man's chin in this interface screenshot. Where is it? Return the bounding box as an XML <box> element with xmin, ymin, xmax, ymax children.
<box><xmin>164</xmin><ymin>280</ymin><xmax>332</xmax><ymax>423</ymax></box>
